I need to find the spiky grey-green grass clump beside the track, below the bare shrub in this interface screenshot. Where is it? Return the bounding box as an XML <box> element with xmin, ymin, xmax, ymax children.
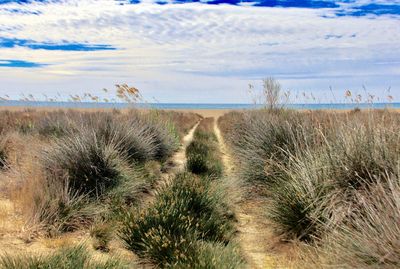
<box><xmin>223</xmin><ymin>110</ymin><xmax>312</xmax><ymax>184</ymax></box>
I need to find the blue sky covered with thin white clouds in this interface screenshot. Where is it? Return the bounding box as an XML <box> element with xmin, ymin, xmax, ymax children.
<box><xmin>0</xmin><ymin>0</ymin><xmax>400</xmax><ymax>103</ymax></box>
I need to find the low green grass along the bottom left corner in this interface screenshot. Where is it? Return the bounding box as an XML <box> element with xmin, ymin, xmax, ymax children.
<box><xmin>0</xmin><ymin>245</ymin><xmax>128</xmax><ymax>269</ymax></box>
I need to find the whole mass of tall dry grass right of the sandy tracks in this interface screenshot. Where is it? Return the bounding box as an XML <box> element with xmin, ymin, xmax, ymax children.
<box><xmin>220</xmin><ymin>110</ymin><xmax>400</xmax><ymax>268</ymax></box>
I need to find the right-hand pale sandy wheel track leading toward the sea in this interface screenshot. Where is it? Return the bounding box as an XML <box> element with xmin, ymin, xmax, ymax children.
<box><xmin>214</xmin><ymin>118</ymin><xmax>291</xmax><ymax>269</ymax></box>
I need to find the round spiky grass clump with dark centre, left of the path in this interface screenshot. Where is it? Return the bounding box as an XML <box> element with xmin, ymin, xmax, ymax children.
<box><xmin>43</xmin><ymin>130</ymin><xmax>126</xmax><ymax>196</ymax></box>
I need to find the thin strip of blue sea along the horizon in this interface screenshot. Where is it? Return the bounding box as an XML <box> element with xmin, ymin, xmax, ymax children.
<box><xmin>0</xmin><ymin>101</ymin><xmax>400</xmax><ymax>110</ymax></box>
